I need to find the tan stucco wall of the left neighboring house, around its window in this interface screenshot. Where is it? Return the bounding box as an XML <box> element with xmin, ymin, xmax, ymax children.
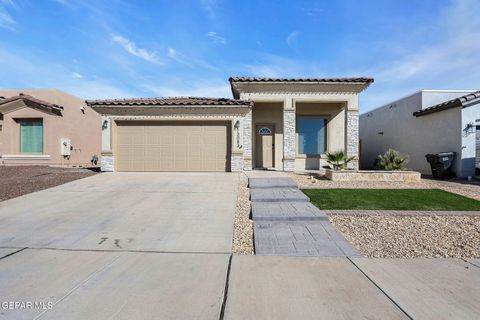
<box><xmin>0</xmin><ymin>90</ymin><xmax>101</xmax><ymax>166</ymax></box>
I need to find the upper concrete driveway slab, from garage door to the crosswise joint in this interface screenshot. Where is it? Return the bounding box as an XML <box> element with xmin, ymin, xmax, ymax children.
<box><xmin>0</xmin><ymin>173</ymin><xmax>238</xmax><ymax>253</ymax></box>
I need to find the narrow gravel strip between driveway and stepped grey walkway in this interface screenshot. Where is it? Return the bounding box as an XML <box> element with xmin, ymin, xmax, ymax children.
<box><xmin>232</xmin><ymin>174</ymin><xmax>254</xmax><ymax>255</ymax></box>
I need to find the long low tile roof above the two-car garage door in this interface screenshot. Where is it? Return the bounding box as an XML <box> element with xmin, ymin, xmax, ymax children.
<box><xmin>86</xmin><ymin>97</ymin><xmax>253</xmax><ymax>106</ymax></box>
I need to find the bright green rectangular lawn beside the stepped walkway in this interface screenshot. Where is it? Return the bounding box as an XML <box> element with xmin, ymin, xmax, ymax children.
<box><xmin>302</xmin><ymin>189</ymin><xmax>480</xmax><ymax>211</ymax></box>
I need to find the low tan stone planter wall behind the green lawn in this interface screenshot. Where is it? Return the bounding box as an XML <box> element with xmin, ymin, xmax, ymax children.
<box><xmin>325</xmin><ymin>169</ymin><xmax>420</xmax><ymax>182</ymax></box>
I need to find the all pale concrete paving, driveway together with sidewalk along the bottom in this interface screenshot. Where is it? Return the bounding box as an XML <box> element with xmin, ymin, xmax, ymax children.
<box><xmin>0</xmin><ymin>173</ymin><xmax>480</xmax><ymax>319</ymax></box>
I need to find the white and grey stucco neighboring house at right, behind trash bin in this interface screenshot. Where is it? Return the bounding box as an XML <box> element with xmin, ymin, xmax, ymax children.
<box><xmin>360</xmin><ymin>90</ymin><xmax>480</xmax><ymax>177</ymax></box>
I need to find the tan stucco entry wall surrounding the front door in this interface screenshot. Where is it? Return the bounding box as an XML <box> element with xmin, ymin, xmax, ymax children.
<box><xmin>252</xmin><ymin>102</ymin><xmax>283</xmax><ymax>170</ymax></box>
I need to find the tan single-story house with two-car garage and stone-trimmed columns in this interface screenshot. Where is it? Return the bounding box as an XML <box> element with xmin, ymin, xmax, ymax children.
<box><xmin>87</xmin><ymin>78</ymin><xmax>373</xmax><ymax>171</ymax></box>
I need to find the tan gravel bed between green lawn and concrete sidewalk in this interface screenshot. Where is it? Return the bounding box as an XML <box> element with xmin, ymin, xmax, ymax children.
<box><xmin>329</xmin><ymin>215</ymin><xmax>480</xmax><ymax>258</ymax></box>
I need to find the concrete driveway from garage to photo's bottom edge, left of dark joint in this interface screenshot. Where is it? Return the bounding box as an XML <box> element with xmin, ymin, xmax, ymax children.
<box><xmin>0</xmin><ymin>173</ymin><xmax>239</xmax><ymax>319</ymax></box>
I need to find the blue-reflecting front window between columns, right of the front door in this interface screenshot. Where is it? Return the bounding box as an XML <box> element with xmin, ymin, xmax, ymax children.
<box><xmin>297</xmin><ymin>117</ymin><xmax>326</xmax><ymax>154</ymax></box>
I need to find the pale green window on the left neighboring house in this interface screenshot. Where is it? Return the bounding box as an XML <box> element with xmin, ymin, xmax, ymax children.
<box><xmin>19</xmin><ymin>119</ymin><xmax>43</xmax><ymax>153</ymax></box>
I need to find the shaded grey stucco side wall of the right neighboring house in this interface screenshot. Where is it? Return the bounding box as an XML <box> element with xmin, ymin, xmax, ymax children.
<box><xmin>360</xmin><ymin>92</ymin><xmax>464</xmax><ymax>174</ymax></box>
